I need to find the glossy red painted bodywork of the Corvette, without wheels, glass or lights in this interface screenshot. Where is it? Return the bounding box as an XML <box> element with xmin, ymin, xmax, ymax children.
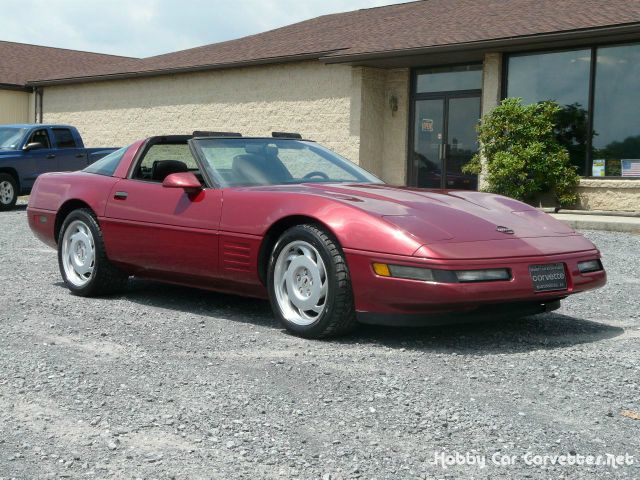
<box><xmin>28</xmin><ymin>141</ymin><xmax>606</xmax><ymax>313</ymax></box>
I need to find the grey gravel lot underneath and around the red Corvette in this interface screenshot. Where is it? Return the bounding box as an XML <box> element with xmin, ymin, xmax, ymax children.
<box><xmin>0</xmin><ymin>200</ymin><xmax>640</xmax><ymax>479</ymax></box>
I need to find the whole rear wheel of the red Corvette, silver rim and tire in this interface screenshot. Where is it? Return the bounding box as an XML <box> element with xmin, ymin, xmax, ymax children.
<box><xmin>58</xmin><ymin>208</ymin><xmax>128</xmax><ymax>297</ymax></box>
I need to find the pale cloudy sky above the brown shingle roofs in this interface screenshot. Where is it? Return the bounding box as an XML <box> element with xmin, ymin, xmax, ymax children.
<box><xmin>0</xmin><ymin>0</ymin><xmax>406</xmax><ymax>57</ymax></box>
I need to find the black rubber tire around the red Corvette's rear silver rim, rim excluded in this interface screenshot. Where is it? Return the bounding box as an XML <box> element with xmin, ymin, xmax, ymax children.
<box><xmin>58</xmin><ymin>208</ymin><xmax>129</xmax><ymax>297</ymax></box>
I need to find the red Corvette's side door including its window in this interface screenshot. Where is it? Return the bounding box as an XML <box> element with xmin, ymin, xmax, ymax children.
<box><xmin>102</xmin><ymin>140</ymin><xmax>222</xmax><ymax>283</ymax></box>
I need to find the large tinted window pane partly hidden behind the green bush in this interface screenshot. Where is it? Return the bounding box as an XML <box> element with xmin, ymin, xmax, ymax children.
<box><xmin>507</xmin><ymin>49</ymin><xmax>591</xmax><ymax>174</ymax></box>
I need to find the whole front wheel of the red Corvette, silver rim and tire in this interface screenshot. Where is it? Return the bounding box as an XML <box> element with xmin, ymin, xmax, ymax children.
<box><xmin>267</xmin><ymin>225</ymin><xmax>356</xmax><ymax>338</ymax></box>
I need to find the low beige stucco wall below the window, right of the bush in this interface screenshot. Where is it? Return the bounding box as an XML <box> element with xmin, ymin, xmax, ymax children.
<box><xmin>578</xmin><ymin>178</ymin><xmax>640</xmax><ymax>212</ymax></box>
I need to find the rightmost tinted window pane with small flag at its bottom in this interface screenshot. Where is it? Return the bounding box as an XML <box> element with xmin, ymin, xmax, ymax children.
<box><xmin>589</xmin><ymin>44</ymin><xmax>640</xmax><ymax>177</ymax></box>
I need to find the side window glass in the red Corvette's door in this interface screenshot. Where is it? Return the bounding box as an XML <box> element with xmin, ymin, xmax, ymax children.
<box><xmin>131</xmin><ymin>143</ymin><xmax>203</xmax><ymax>183</ymax></box>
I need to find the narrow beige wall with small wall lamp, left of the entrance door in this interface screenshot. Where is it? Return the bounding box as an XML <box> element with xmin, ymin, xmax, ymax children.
<box><xmin>352</xmin><ymin>67</ymin><xmax>409</xmax><ymax>185</ymax></box>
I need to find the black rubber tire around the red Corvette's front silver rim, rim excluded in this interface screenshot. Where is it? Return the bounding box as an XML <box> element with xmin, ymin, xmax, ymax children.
<box><xmin>267</xmin><ymin>224</ymin><xmax>357</xmax><ymax>338</ymax></box>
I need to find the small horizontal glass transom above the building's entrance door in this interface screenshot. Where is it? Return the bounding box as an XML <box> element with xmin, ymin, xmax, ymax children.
<box><xmin>416</xmin><ymin>65</ymin><xmax>482</xmax><ymax>93</ymax></box>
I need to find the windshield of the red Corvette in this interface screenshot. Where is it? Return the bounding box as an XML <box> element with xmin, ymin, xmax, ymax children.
<box><xmin>193</xmin><ymin>138</ymin><xmax>383</xmax><ymax>187</ymax></box>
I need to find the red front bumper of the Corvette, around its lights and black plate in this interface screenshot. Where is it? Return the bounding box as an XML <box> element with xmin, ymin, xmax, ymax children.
<box><xmin>345</xmin><ymin>249</ymin><xmax>606</xmax><ymax>324</ymax></box>
